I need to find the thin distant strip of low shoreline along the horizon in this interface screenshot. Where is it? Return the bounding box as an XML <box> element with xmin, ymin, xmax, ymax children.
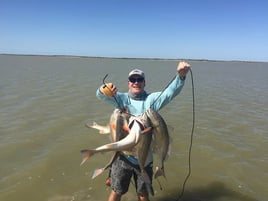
<box><xmin>0</xmin><ymin>53</ymin><xmax>268</xmax><ymax>63</ymax></box>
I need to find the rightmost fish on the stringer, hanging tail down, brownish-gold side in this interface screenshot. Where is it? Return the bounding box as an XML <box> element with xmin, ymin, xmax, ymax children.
<box><xmin>145</xmin><ymin>109</ymin><xmax>170</xmax><ymax>178</ymax></box>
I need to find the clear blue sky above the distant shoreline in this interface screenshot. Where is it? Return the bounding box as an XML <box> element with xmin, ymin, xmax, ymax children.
<box><xmin>0</xmin><ymin>0</ymin><xmax>268</xmax><ymax>61</ymax></box>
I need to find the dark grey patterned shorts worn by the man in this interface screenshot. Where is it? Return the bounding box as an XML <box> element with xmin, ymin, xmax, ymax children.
<box><xmin>110</xmin><ymin>155</ymin><xmax>153</xmax><ymax>195</ymax></box>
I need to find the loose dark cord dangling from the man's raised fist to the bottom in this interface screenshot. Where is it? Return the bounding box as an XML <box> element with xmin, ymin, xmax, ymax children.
<box><xmin>178</xmin><ymin>68</ymin><xmax>195</xmax><ymax>201</ymax></box>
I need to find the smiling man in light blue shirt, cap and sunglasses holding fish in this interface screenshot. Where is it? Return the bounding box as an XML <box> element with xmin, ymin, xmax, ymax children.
<box><xmin>96</xmin><ymin>62</ymin><xmax>190</xmax><ymax>201</ymax></box>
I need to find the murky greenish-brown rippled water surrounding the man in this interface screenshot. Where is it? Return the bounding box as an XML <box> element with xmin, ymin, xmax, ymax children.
<box><xmin>0</xmin><ymin>55</ymin><xmax>268</xmax><ymax>201</ymax></box>
